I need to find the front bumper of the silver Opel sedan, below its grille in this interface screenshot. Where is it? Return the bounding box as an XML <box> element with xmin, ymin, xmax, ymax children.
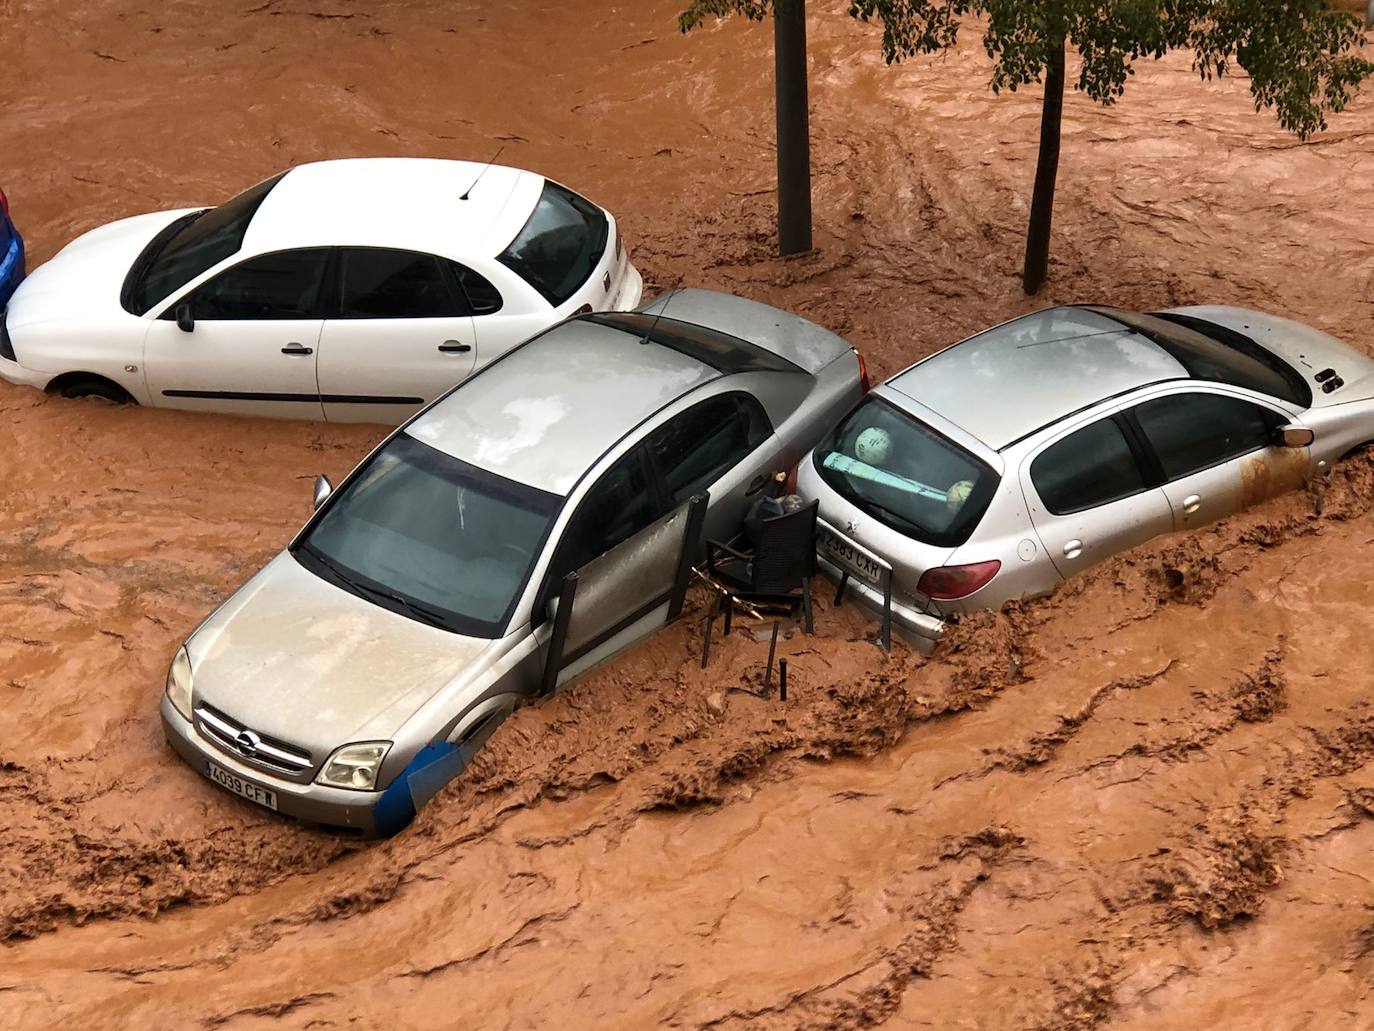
<box><xmin>162</xmin><ymin>696</ymin><xmax>398</xmax><ymax>836</ymax></box>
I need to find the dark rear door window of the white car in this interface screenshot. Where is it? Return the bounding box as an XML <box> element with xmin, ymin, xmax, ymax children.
<box><xmin>338</xmin><ymin>247</ymin><xmax>467</xmax><ymax>319</ymax></box>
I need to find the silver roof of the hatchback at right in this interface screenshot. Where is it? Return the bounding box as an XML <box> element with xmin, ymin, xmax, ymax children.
<box><xmin>888</xmin><ymin>307</ymin><xmax>1187</xmax><ymax>450</ymax></box>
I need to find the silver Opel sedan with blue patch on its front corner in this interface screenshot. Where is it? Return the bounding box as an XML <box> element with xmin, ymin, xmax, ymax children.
<box><xmin>162</xmin><ymin>290</ymin><xmax>861</xmax><ymax>834</ymax></box>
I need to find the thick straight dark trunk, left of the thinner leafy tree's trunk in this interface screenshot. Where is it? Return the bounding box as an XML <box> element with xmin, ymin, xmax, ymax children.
<box><xmin>774</xmin><ymin>0</ymin><xmax>811</xmax><ymax>254</ymax></box>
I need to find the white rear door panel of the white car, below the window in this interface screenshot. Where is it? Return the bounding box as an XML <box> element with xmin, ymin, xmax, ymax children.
<box><xmin>317</xmin><ymin>318</ymin><xmax>478</xmax><ymax>426</ymax></box>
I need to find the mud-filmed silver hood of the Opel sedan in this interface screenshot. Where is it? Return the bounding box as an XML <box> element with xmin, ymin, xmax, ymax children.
<box><xmin>187</xmin><ymin>551</ymin><xmax>493</xmax><ymax>766</ymax></box>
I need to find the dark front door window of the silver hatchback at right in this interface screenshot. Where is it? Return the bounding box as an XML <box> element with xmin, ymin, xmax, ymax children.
<box><xmin>1134</xmin><ymin>393</ymin><xmax>1283</xmax><ymax>480</ymax></box>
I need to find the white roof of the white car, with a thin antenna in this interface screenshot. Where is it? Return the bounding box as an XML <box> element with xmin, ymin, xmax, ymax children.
<box><xmin>243</xmin><ymin>158</ymin><xmax>544</xmax><ymax>258</ymax></box>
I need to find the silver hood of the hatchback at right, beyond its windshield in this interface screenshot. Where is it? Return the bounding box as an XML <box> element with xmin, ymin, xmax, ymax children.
<box><xmin>1169</xmin><ymin>305</ymin><xmax>1374</xmax><ymax>408</ymax></box>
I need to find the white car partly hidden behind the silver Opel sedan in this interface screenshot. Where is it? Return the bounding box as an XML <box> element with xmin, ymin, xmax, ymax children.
<box><xmin>0</xmin><ymin>158</ymin><xmax>643</xmax><ymax>423</ymax></box>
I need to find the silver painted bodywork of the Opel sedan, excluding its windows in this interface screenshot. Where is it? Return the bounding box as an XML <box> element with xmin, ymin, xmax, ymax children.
<box><xmin>162</xmin><ymin>291</ymin><xmax>861</xmax><ymax>833</ymax></box>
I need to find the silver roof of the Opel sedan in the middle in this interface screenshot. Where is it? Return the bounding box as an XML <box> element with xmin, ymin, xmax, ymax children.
<box><xmin>407</xmin><ymin>319</ymin><xmax>721</xmax><ymax>495</ymax></box>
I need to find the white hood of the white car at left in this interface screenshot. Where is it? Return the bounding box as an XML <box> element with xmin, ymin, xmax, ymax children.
<box><xmin>8</xmin><ymin>208</ymin><xmax>199</xmax><ymax>331</ymax></box>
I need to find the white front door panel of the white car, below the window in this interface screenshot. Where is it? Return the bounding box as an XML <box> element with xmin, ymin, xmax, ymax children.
<box><xmin>143</xmin><ymin>319</ymin><xmax>324</xmax><ymax>419</ymax></box>
